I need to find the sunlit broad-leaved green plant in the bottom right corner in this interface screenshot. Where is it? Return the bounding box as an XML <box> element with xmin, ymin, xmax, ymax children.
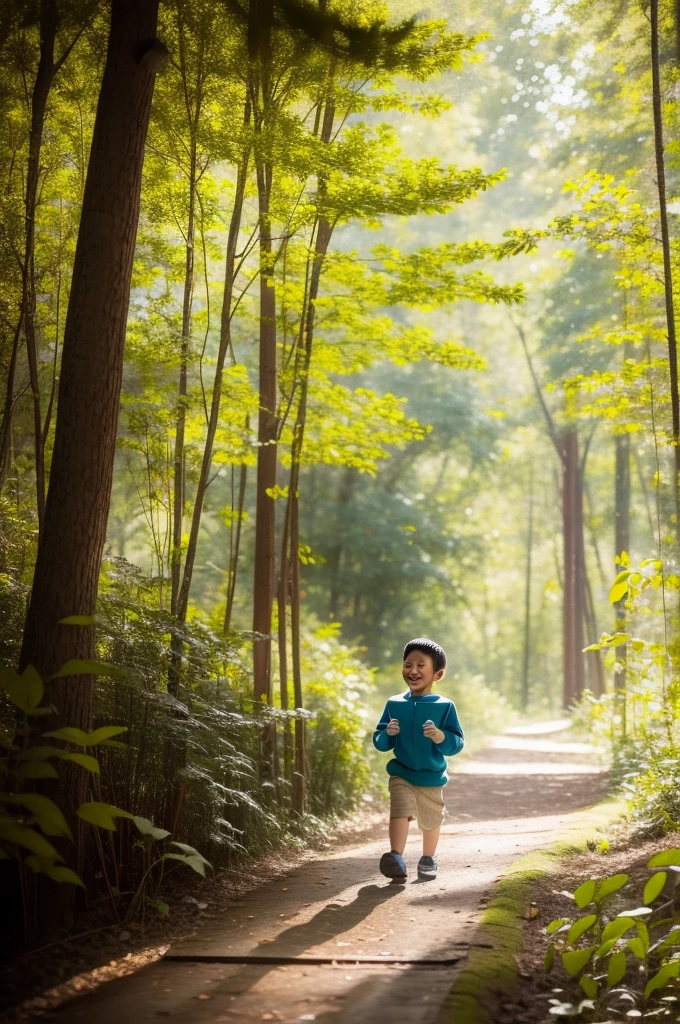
<box><xmin>545</xmin><ymin>849</ymin><xmax>680</xmax><ymax>1021</ymax></box>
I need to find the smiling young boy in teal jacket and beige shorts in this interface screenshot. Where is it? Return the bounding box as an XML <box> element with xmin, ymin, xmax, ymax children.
<box><xmin>373</xmin><ymin>637</ymin><xmax>463</xmax><ymax>885</ymax></box>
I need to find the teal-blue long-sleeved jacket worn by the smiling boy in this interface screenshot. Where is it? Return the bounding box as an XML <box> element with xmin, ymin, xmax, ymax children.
<box><xmin>373</xmin><ymin>691</ymin><xmax>463</xmax><ymax>785</ymax></box>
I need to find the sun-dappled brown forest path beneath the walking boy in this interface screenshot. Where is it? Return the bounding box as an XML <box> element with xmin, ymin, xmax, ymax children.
<box><xmin>42</xmin><ymin>722</ymin><xmax>606</xmax><ymax>1024</ymax></box>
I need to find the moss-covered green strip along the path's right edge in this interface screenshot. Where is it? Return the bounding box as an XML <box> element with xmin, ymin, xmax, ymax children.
<box><xmin>437</xmin><ymin>799</ymin><xmax>626</xmax><ymax>1024</ymax></box>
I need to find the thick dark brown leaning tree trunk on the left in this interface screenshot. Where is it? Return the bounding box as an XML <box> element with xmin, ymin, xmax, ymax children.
<box><xmin>20</xmin><ymin>0</ymin><xmax>166</xmax><ymax>811</ymax></box>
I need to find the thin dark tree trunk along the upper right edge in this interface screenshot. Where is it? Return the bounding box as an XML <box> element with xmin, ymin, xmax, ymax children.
<box><xmin>649</xmin><ymin>0</ymin><xmax>680</xmax><ymax>543</ymax></box>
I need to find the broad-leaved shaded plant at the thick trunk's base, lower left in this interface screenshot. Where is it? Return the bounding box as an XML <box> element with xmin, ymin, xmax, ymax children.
<box><xmin>0</xmin><ymin>660</ymin><xmax>210</xmax><ymax>916</ymax></box>
